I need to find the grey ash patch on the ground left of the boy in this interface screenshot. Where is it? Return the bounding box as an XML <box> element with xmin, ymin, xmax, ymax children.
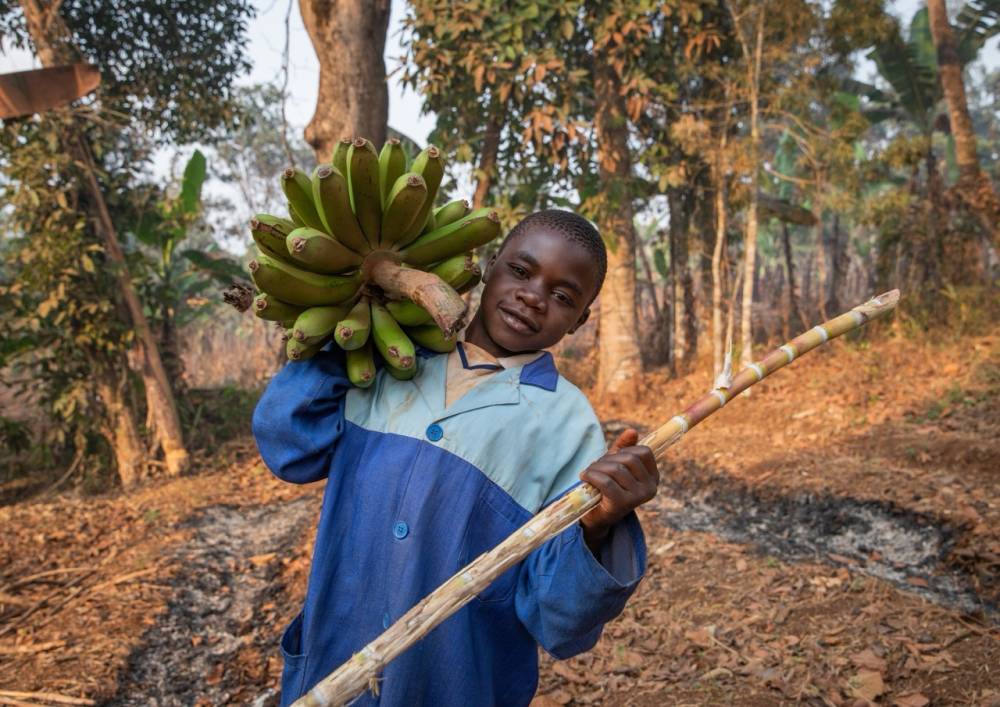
<box><xmin>105</xmin><ymin>497</ymin><xmax>317</xmax><ymax>707</ymax></box>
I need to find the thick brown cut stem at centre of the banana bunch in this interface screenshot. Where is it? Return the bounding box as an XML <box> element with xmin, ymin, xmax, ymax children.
<box><xmin>363</xmin><ymin>258</ymin><xmax>469</xmax><ymax>338</ymax></box>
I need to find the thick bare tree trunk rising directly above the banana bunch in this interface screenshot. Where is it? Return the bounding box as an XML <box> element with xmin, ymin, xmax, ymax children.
<box><xmin>299</xmin><ymin>0</ymin><xmax>389</xmax><ymax>162</ymax></box>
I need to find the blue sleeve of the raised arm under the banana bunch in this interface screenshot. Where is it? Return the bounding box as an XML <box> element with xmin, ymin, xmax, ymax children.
<box><xmin>253</xmin><ymin>351</ymin><xmax>351</xmax><ymax>484</ymax></box>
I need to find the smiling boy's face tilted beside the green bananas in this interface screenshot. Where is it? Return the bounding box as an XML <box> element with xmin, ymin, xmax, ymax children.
<box><xmin>477</xmin><ymin>227</ymin><xmax>597</xmax><ymax>355</ymax></box>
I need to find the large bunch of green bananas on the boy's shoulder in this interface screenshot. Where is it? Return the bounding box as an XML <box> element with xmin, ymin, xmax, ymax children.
<box><xmin>250</xmin><ymin>138</ymin><xmax>500</xmax><ymax>387</ymax></box>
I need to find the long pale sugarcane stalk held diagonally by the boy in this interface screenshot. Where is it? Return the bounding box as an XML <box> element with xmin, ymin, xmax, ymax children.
<box><xmin>294</xmin><ymin>290</ymin><xmax>899</xmax><ymax>707</ymax></box>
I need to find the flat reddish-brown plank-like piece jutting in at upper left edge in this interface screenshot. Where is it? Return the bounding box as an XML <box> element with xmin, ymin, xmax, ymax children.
<box><xmin>0</xmin><ymin>63</ymin><xmax>101</xmax><ymax>120</ymax></box>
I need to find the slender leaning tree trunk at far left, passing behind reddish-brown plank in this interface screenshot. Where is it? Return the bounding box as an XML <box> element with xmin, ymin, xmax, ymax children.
<box><xmin>21</xmin><ymin>0</ymin><xmax>189</xmax><ymax>475</ymax></box>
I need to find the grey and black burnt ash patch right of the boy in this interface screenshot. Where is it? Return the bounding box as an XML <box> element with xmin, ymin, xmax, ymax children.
<box><xmin>656</xmin><ymin>463</ymin><xmax>1000</xmax><ymax>623</ymax></box>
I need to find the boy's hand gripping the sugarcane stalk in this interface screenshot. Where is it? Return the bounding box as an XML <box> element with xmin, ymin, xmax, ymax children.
<box><xmin>580</xmin><ymin>429</ymin><xmax>660</xmax><ymax>551</ymax></box>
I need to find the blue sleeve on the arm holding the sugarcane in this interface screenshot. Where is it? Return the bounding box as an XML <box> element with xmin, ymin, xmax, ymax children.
<box><xmin>514</xmin><ymin>412</ymin><xmax>646</xmax><ymax>659</ymax></box>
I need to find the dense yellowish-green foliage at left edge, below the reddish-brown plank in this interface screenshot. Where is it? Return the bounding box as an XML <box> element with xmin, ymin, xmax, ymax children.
<box><xmin>0</xmin><ymin>115</ymin><xmax>131</xmax><ymax>460</ymax></box>
